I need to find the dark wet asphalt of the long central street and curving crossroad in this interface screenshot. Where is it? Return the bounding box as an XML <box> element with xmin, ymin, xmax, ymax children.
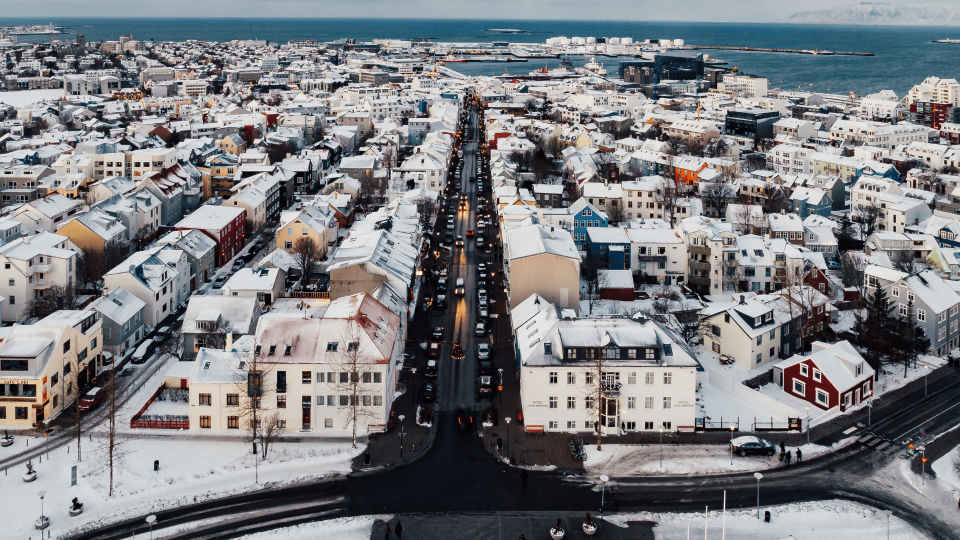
<box><xmin>62</xmin><ymin>103</ymin><xmax>960</xmax><ymax>540</ymax></box>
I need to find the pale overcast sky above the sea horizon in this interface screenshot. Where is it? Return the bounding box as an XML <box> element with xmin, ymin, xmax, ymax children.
<box><xmin>0</xmin><ymin>0</ymin><xmax>957</xmax><ymax>20</ymax></box>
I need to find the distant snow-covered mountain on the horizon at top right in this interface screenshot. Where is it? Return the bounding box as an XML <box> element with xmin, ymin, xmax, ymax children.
<box><xmin>786</xmin><ymin>2</ymin><xmax>960</xmax><ymax>26</ymax></box>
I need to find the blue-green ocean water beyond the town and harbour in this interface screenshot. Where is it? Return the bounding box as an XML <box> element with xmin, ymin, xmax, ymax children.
<box><xmin>0</xmin><ymin>17</ymin><xmax>960</xmax><ymax>96</ymax></box>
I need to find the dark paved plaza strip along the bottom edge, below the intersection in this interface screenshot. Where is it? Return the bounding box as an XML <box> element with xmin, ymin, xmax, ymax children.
<box><xmin>370</xmin><ymin>512</ymin><xmax>655</xmax><ymax>540</ymax></box>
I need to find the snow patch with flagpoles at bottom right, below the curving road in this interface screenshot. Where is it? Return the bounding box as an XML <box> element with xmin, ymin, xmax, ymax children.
<box><xmin>601</xmin><ymin>500</ymin><xmax>928</xmax><ymax>540</ymax></box>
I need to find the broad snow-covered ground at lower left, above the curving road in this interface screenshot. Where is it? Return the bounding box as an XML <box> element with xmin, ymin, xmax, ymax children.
<box><xmin>0</xmin><ymin>436</ymin><xmax>363</xmax><ymax>538</ymax></box>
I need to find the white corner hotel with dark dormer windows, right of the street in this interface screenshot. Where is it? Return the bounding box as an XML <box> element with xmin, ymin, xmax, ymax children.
<box><xmin>511</xmin><ymin>295</ymin><xmax>699</xmax><ymax>435</ymax></box>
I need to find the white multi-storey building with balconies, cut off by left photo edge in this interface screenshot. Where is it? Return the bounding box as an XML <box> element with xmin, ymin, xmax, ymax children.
<box><xmin>0</xmin><ymin>232</ymin><xmax>77</xmax><ymax>323</ymax></box>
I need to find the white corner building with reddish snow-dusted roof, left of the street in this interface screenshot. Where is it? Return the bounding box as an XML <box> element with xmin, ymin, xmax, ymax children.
<box><xmin>189</xmin><ymin>293</ymin><xmax>403</xmax><ymax>435</ymax></box>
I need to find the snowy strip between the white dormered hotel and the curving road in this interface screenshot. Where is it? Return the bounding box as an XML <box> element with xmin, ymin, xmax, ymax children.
<box><xmin>583</xmin><ymin>437</ymin><xmax>853</xmax><ymax>478</ymax></box>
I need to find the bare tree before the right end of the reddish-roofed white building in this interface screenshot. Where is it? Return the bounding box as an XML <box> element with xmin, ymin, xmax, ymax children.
<box><xmin>334</xmin><ymin>322</ymin><xmax>382</xmax><ymax>448</ymax></box>
